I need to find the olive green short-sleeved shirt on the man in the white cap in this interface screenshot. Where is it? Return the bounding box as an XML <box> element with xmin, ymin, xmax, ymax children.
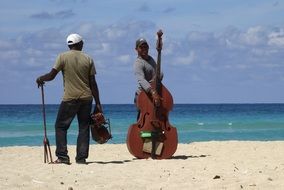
<box><xmin>53</xmin><ymin>50</ymin><xmax>96</xmax><ymax>101</ymax></box>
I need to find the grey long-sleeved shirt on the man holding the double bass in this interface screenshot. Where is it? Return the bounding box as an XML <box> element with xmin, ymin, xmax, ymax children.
<box><xmin>134</xmin><ymin>56</ymin><xmax>162</xmax><ymax>94</ymax></box>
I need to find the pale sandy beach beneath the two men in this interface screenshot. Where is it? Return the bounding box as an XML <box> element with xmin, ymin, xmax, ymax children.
<box><xmin>0</xmin><ymin>141</ymin><xmax>284</xmax><ymax>190</ymax></box>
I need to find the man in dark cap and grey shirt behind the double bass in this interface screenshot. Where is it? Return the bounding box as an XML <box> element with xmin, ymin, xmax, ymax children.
<box><xmin>134</xmin><ymin>38</ymin><xmax>161</xmax><ymax>120</ymax></box>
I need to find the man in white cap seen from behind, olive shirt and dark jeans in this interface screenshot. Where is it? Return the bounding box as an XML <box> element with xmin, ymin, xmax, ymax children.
<box><xmin>36</xmin><ymin>34</ymin><xmax>102</xmax><ymax>164</ymax></box>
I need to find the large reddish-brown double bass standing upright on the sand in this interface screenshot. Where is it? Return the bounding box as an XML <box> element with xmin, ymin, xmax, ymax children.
<box><xmin>126</xmin><ymin>30</ymin><xmax>178</xmax><ymax>159</ymax></box>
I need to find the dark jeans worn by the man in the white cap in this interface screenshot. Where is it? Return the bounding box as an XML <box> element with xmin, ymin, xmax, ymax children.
<box><xmin>55</xmin><ymin>100</ymin><xmax>92</xmax><ymax>160</ymax></box>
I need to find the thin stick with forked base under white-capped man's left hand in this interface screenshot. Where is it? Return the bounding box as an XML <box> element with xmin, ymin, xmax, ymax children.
<box><xmin>40</xmin><ymin>85</ymin><xmax>52</xmax><ymax>163</ymax></box>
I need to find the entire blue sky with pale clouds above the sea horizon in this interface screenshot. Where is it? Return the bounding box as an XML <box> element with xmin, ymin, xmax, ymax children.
<box><xmin>0</xmin><ymin>0</ymin><xmax>284</xmax><ymax>104</ymax></box>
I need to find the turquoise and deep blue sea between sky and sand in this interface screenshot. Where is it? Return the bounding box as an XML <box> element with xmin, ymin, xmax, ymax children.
<box><xmin>0</xmin><ymin>104</ymin><xmax>284</xmax><ymax>147</ymax></box>
